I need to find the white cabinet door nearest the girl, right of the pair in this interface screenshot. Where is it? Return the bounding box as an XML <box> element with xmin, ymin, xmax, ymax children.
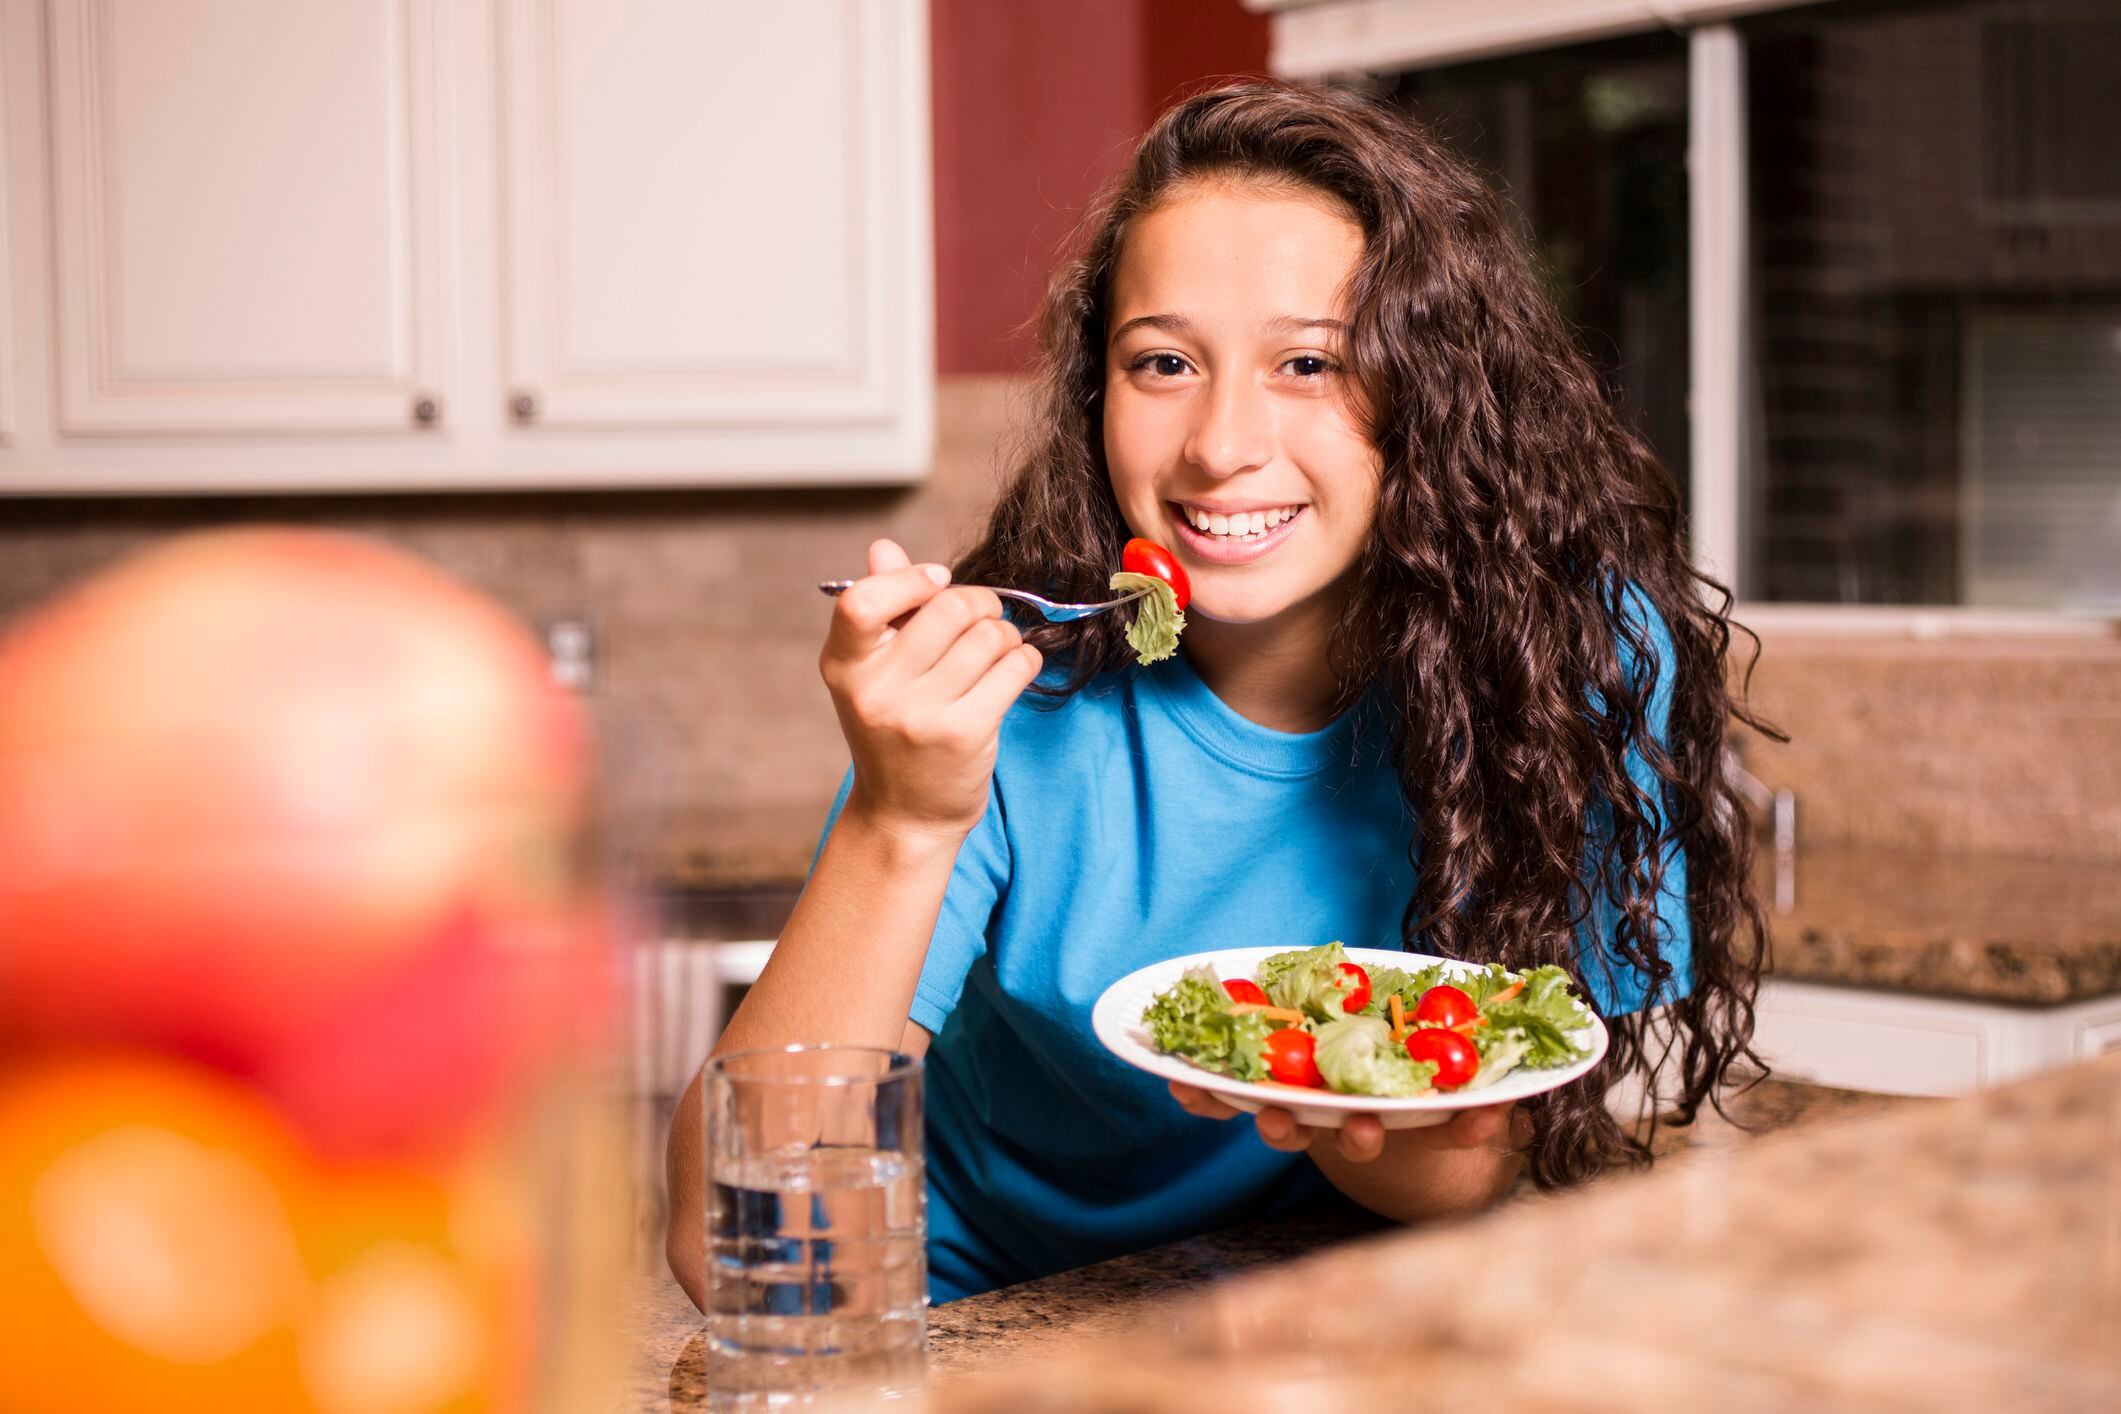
<box><xmin>501</xmin><ymin>0</ymin><xmax>933</xmax><ymax>479</ymax></box>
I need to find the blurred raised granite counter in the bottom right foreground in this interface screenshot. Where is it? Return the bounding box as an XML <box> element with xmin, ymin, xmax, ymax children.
<box><xmin>931</xmin><ymin>1056</ymin><xmax>2121</xmax><ymax>1414</ymax></box>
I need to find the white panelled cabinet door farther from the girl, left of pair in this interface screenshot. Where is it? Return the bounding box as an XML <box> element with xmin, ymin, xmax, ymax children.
<box><xmin>49</xmin><ymin>0</ymin><xmax>448</xmax><ymax>437</ymax></box>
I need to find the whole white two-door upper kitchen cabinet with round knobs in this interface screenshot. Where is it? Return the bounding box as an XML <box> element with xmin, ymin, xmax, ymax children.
<box><xmin>0</xmin><ymin>0</ymin><xmax>933</xmax><ymax>494</ymax></box>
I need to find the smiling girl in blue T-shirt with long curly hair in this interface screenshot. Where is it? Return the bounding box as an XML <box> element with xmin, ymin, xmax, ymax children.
<box><xmin>670</xmin><ymin>85</ymin><xmax>1765</xmax><ymax>1302</ymax></box>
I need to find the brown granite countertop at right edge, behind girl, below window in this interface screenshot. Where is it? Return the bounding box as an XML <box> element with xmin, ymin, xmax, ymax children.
<box><xmin>1760</xmin><ymin>846</ymin><xmax>2121</xmax><ymax>1005</ymax></box>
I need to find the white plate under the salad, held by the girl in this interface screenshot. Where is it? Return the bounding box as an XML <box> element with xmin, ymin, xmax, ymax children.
<box><xmin>1090</xmin><ymin>948</ymin><xmax>1606</xmax><ymax>1130</ymax></box>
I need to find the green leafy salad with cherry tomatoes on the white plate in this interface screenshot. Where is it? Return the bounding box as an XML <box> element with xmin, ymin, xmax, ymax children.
<box><xmin>1141</xmin><ymin>943</ymin><xmax>1591</xmax><ymax>1098</ymax></box>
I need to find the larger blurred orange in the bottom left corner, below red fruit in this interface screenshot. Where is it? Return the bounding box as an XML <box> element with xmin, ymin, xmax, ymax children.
<box><xmin>0</xmin><ymin>1058</ymin><xmax>310</xmax><ymax>1414</ymax></box>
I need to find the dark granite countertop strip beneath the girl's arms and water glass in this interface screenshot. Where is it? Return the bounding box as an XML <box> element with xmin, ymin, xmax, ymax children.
<box><xmin>626</xmin><ymin>1081</ymin><xmax>1936</xmax><ymax>1410</ymax></box>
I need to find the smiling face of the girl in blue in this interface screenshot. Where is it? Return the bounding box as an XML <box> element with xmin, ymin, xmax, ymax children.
<box><xmin>1105</xmin><ymin>182</ymin><xmax>1379</xmax><ymax>623</ymax></box>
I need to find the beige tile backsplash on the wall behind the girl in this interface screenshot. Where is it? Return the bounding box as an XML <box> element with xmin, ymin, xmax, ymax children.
<box><xmin>0</xmin><ymin>377</ymin><xmax>2121</xmax><ymax>886</ymax></box>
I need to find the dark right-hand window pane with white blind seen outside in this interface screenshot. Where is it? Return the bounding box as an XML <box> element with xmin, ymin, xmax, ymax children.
<box><xmin>1743</xmin><ymin>2</ymin><xmax>2121</xmax><ymax>611</ymax></box>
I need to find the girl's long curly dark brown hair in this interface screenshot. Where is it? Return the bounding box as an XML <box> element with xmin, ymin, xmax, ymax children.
<box><xmin>957</xmin><ymin>83</ymin><xmax>1780</xmax><ymax>1187</ymax></box>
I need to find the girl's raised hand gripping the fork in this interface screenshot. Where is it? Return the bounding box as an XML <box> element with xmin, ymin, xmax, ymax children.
<box><xmin>819</xmin><ymin>541</ymin><xmax>1041</xmax><ymax>839</ymax></box>
